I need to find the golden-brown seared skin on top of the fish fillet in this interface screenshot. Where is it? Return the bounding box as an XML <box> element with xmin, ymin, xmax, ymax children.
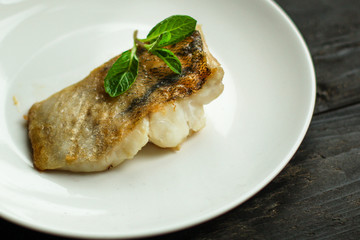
<box><xmin>28</xmin><ymin>28</ymin><xmax>222</xmax><ymax>170</ymax></box>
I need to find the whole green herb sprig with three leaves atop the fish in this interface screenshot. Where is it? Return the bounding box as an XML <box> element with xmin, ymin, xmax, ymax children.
<box><xmin>104</xmin><ymin>15</ymin><xmax>196</xmax><ymax>97</ymax></box>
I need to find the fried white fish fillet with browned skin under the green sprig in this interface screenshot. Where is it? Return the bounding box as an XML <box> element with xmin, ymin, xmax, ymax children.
<box><xmin>28</xmin><ymin>27</ymin><xmax>224</xmax><ymax>172</ymax></box>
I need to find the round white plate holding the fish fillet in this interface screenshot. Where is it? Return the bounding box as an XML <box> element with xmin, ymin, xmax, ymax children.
<box><xmin>0</xmin><ymin>0</ymin><xmax>315</xmax><ymax>238</ymax></box>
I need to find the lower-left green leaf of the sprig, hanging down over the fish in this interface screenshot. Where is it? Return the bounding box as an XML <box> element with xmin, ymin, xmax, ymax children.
<box><xmin>104</xmin><ymin>46</ymin><xmax>139</xmax><ymax>97</ymax></box>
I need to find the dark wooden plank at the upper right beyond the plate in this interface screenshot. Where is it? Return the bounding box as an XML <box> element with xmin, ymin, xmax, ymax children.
<box><xmin>276</xmin><ymin>0</ymin><xmax>360</xmax><ymax>113</ymax></box>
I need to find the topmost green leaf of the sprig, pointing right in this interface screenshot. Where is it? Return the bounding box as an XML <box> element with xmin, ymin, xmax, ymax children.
<box><xmin>142</xmin><ymin>15</ymin><xmax>197</xmax><ymax>47</ymax></box>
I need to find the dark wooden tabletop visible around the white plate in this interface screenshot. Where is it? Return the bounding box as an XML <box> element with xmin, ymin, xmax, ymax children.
<box><xmin>0</xmin><ymin>0</ymin><xmax>360</xmax><ymax>240</ymax></box>
